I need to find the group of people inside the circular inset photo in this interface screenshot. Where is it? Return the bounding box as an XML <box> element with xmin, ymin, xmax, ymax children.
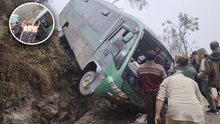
<box><xmin>11</xmin><ymin>21</ymin><xmax>41</xmax><ymax>43</ymax></box>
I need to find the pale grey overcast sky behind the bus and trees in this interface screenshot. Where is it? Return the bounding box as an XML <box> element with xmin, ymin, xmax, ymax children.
<box><xmin>46</xmin><ymin>0</ymin><xmax>220</xmax><ymax>53</ymax></box>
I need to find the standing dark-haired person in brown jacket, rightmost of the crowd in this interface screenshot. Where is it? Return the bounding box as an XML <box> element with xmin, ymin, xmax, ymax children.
<box><xmin>199</xmin><ymin>41</ymin><xmax>220</xmax><ymax>114</ymax></box>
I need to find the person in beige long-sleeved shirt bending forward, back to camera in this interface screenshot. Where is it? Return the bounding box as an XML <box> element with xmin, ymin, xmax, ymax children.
<box><xmin>155</xmin><ymin>70</ymin><xmax>204</xmax><ymax>124</ymax></box>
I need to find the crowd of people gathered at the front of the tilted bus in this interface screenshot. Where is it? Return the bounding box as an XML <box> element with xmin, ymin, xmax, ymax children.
<box><xmin>137</xmin><ymin>41</ymin><xmax>220</xmax><ymax>124</ymax></box>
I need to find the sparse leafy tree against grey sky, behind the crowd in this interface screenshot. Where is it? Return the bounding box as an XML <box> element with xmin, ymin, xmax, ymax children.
<box><xmin>161</xmin><ymin>12</ymin><xmax>199</xmax><ymax>56</ymax></box>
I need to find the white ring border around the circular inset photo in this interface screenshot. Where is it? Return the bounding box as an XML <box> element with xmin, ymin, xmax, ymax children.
<box><xmin>8</xmin><ymin>2</ymin><xmax>55</xmax><ymax>45</ymax></box>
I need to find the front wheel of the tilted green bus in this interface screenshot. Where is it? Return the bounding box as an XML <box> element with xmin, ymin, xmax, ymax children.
<box><xmin>79</xmin><ymin>71</ymin><xmax>95</xmax><ymax>96</ymax></box>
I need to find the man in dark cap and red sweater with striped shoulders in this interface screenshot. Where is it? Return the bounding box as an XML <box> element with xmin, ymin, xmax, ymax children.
<box><xmin>137</xmin><ymin>50</ymin><xmax>167</xmax><ymax>124</ymax></box>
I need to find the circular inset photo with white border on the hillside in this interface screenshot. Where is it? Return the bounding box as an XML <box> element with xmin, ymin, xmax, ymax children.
<box><xmin>9</xmin><ymin>2</ymin><xmax>55</xmax><ymax>45</ymax></box>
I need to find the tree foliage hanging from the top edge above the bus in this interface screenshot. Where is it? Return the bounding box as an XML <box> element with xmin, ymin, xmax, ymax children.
<box><xmin>112</xmin><ymin>0</ymin><xmax>148</xmax><ymax>11</ymax></box>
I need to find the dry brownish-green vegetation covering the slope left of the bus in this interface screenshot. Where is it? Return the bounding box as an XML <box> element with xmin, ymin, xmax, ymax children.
<box><xmin>0</xmin><ymin>0</ymin><xmax>80</xmax><ymax>123</ymax></box>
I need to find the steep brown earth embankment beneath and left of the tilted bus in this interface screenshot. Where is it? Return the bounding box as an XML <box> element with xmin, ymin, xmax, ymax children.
<box><xmin>0</xmin><ymin>31</ymin><xmax>141</xmax><ymax>124</ymax></box>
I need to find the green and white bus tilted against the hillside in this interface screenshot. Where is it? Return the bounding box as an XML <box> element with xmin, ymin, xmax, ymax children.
<box><xmin>59</xmin><ymin>0</ymin><xmax>173</xmax><ymax>108</ymax></box>
